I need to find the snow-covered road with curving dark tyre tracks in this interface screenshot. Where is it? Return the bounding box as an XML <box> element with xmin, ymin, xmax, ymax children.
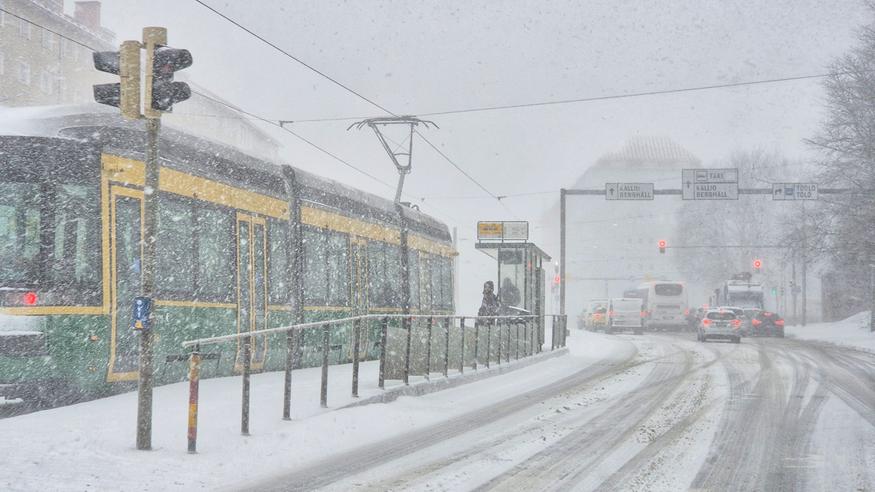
<box><xmin>264</xmin><ymin>335</ymin><xmax>875</xmax><ymax>490</ymax></box>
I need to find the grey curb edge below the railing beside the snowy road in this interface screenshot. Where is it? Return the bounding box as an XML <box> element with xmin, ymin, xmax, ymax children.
<box><xmin>338</xmin><ymin>347</ymin><xmax>568</xmax><ymax>409</ymax></box>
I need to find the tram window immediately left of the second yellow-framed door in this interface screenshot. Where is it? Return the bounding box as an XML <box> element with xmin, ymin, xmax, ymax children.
<box><xmin>195</xmin><ymin>207</ymin><xmax>235</xmax><ymax>301</ymax></box>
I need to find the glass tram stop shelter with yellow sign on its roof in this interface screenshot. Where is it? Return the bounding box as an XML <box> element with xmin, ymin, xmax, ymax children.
<box><xmin>475</xmin><ymin>221</ymin><xmax>550</xmax><ymax>322</ymax></box>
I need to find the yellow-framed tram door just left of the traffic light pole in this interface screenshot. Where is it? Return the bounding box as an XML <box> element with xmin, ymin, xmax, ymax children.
<box><xmin>106</xmin><ymin>186</ymin><xmax>143</xmax><ymax>381</ymax></box>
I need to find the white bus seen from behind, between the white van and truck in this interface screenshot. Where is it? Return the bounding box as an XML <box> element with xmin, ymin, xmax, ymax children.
<box><xmin>636</xmin><ymin>280</ymin><xmax>690</xmax><ymax>330</ymax></box>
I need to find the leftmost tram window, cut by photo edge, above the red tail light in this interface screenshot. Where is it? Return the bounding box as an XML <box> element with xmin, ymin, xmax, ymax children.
<box><xmin>0</xmin><ymin>182</ymin><xmax>42</xmax><ymax>284</ymax></box>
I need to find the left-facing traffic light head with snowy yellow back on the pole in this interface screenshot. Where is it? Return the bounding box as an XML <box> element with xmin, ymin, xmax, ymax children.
<box><xmin>94</xmin><ymin>41</ymin><xmax>140</xmax><ymax>119</ymax></box>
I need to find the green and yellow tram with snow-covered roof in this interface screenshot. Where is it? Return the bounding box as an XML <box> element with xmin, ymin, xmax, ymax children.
<box><xmin>0</xmin><ymin>106</ymin><xmax>455</xmax><ymax>400</ymax></box>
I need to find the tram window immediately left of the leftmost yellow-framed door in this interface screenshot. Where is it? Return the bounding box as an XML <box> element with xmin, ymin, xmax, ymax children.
<box><xmin>52</xmin><ymin>185</ymin><xmax>100</xmax><ymax>285</ymax></box>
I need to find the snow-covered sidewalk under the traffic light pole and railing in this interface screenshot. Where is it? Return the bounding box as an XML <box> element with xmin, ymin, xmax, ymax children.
<box><xmin>0</xmin><ymin>331</ymin><xmax>635</xmax><ymax>490</ymax></box>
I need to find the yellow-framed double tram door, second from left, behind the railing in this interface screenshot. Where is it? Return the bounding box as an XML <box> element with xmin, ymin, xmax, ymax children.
<box><xmin>235</xmin><ymin>213</ymin><xmax>267</xmax><ymax>371</ymax></box>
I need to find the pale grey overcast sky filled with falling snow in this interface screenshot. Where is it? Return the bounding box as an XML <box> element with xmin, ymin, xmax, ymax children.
<box><xmin>68</xmin><ymin>0</ymin><xmax>872</xmax><ymax>308</ymax></box>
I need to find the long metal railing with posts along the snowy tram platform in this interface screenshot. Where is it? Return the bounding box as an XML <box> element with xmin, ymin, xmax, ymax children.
<box><xmin>182</xmin><ymin>314</ymin><xmax>568</xmax><ymax>453</ymax></box>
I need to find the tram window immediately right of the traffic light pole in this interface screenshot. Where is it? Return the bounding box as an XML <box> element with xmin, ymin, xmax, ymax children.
<box><xmin>157</xmin><ymin>195</ymin><xmax>195</xmax><ymax>297</ymax></box>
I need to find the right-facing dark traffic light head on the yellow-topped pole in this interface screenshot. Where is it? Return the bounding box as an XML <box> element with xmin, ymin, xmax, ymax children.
<box><xmin>146</xmin><ymin>45</ymin><xmax>192</xmax><ymax>111</ymax></box>
